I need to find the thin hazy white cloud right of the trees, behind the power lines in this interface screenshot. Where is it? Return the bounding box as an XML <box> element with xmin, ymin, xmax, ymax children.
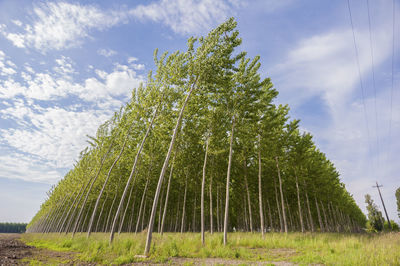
<box><xmin>269</xmin><ymin>7</ymin><xmax>400</xmax><ymax>219</ymax></box>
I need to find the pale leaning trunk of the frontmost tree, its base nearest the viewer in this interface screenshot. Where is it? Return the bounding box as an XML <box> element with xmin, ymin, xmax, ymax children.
<box><xmin>144</xmin><ymin>79</ymin><xmax>197</xmax><ymax>256</ymax></box>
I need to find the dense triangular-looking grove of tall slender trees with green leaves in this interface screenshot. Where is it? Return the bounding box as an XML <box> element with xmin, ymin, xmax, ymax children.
<box><xmin>28</xmin><ymin>19</ymin><xmax>366</xmax><ymax>254</ymax></box>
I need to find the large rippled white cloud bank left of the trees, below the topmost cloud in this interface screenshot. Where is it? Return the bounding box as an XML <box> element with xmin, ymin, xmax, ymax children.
<box><xmin>0</xmin><ymin>55</ymin><xmax>144</xmax><ymax>182</ymax></box>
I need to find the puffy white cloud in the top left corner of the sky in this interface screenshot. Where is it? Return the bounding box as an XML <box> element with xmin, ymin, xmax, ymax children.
<box><xmin>0</xmin><ymin>2</ymin><xmax>125</xmax><ymax>51</ymax></box>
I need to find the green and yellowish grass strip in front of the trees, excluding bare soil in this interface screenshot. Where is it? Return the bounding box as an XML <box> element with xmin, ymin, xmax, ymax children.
<box><xmin>22</xmin><ymin>233</ymin><xmax>400</xmax><ymax>265</ymax></box>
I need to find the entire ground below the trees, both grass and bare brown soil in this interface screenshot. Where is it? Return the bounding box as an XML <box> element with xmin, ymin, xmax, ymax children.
<box><xmin>0</xmin><ymin>232</ymin><xmax>400</xmax><ymax>266</ymax></box>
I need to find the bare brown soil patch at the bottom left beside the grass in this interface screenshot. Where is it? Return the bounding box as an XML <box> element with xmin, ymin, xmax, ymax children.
<box><xmin>0</xmin><ymin>234</ymin><xmax>88</xmax><ymax>266</ymax></box>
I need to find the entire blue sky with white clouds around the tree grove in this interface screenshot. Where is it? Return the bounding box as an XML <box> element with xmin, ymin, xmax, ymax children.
<box><xmin>0</xmin><ymin>0</ymin><xmax>400</xmax><ymax>222</ymax></box>
